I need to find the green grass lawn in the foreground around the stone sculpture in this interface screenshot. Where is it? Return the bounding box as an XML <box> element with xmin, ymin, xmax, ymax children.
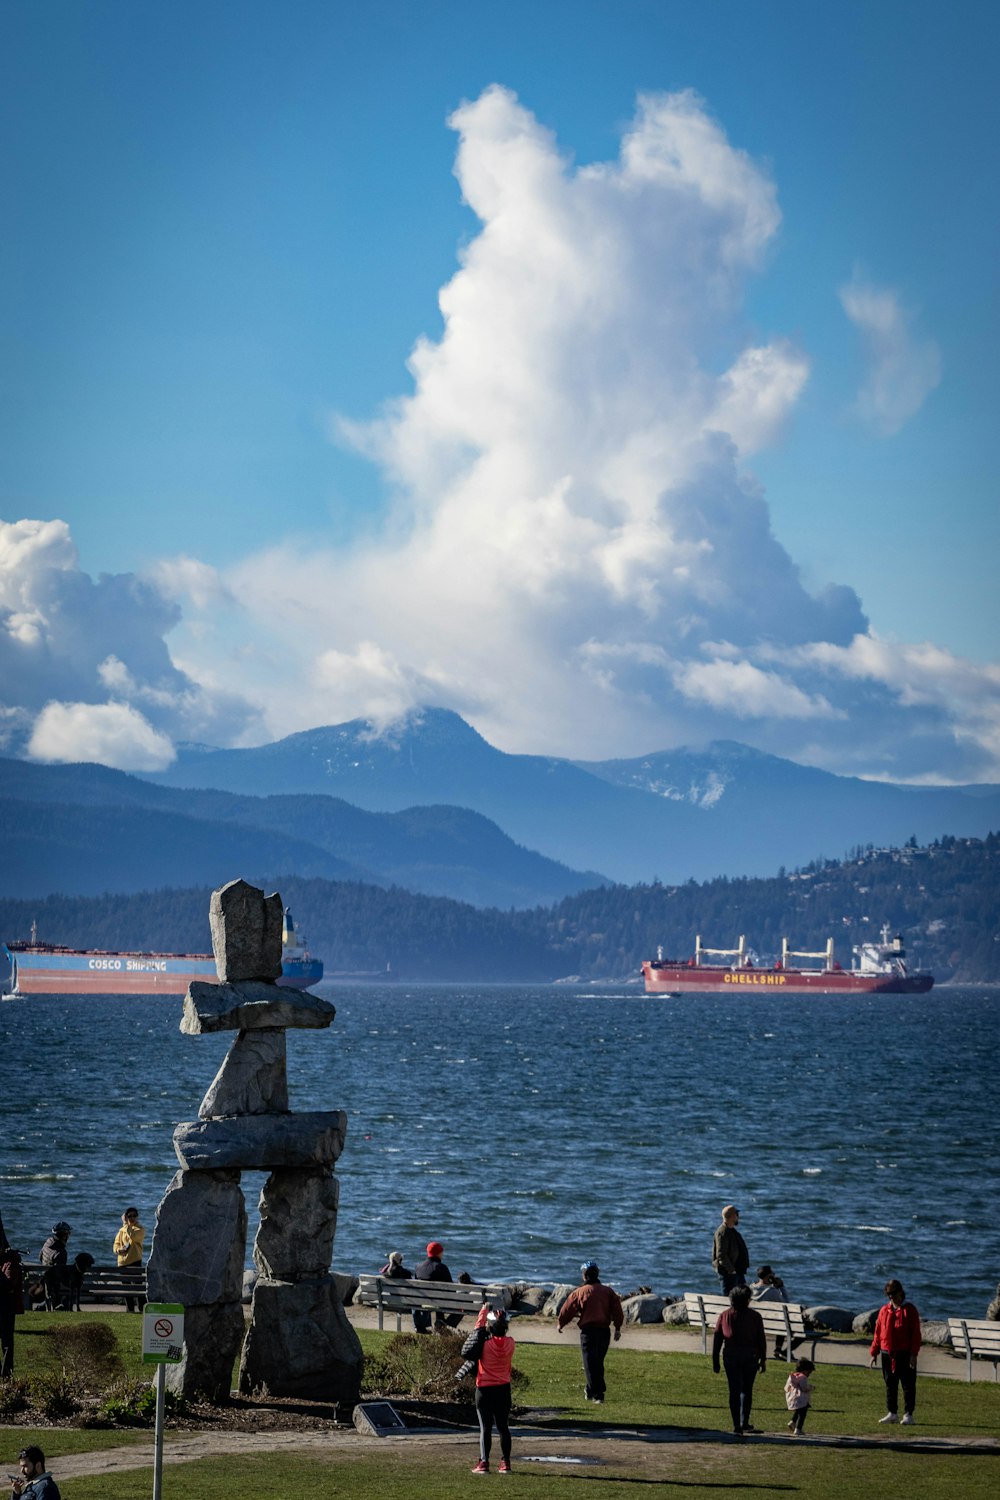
<box><xmin>0</xmin><ymin>1313</ymin><xmax>1000</xmax><ymax>1500</ymax></box>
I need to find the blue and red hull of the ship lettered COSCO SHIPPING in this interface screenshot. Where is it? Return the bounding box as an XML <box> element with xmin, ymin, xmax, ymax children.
<box><xmin>7</xmin><ymin>948</ymin><xmax>322</xmax><ymax>996</ymax></box>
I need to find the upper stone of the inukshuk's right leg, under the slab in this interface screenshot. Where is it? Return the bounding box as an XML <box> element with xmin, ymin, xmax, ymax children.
<box><xmin>253</xmin><ymin>1167</ymin><xmax>340</xmax><ymax>1281</ymax></box>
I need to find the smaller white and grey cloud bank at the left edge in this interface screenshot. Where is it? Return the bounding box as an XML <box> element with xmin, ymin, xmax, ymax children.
<box><xmin>0</xmin><ymin>521</ymin><xmax>255</xmax><ymax>771</ymax></box>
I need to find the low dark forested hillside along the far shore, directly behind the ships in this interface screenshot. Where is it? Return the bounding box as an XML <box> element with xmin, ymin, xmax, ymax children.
<box><xmin>0</xmin><ymin>834</ymin><xmax>1000</xmax><ymax>983</ymax></box>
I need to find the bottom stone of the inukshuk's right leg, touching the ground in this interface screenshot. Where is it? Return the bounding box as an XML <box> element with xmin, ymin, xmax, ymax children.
<box><xmin>240</xmin><ymin>1277</ymin><xmax>364</xmax><ymax>1406</ymax></box>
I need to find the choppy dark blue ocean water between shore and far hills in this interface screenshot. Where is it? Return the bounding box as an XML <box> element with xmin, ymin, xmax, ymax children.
<box><xmin>0</xmin><ymin>984</ymin><xmax>1000</xmax><ymax>1317</ymax></box>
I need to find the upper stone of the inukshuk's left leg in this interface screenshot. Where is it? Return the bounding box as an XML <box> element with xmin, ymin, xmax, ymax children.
<box><xmin>145</xmin><ymin>1172</ymin><xmax>246</xmax><ymax>1308</ymax></box>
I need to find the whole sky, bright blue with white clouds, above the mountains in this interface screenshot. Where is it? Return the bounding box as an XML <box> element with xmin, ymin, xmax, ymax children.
<box><xmin>0</xmin><ymin>0</ymin><xmax>1000</xmax><ymax>780</ymax></box>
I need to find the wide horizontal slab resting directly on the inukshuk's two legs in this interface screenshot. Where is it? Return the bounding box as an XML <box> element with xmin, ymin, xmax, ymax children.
<box><xmin>174</xmin><ymin>1110</ymin><xmax>348</xmax><ymax>1172</ymax></box>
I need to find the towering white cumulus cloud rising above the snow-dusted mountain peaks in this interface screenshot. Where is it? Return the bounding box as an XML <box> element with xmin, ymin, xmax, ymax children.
<box><xmin>199</xmin><ymin>87</ymin><xmax>996</xmax><ymax>777</ymax></box>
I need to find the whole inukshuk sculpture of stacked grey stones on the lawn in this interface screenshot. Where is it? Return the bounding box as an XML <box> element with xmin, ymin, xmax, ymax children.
<box><xmin>147</xmin><ymin>881</ymin><xmax>363</xmax><ymax>1403</ymax></box>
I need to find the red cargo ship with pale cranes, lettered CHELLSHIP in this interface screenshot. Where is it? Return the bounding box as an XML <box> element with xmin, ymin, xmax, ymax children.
<box><xmin>642</xmin><ymin>926</ymin><xmax>934</xmax><ymax>995</ymax></box>
